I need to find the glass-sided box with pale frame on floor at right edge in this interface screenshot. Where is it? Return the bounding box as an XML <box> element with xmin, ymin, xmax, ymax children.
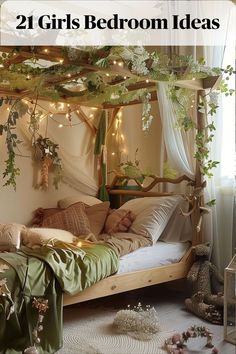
<box><xmin>224</xmin><ymin>254</ymin><xmax>236</xmax><ymax>345</ymax></box>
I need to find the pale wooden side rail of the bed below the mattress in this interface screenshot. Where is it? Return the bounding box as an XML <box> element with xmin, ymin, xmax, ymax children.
<box><xmin>63</xmin><ymin>249</ymin><xmax>193</xmax><ymax>306</ymax></box>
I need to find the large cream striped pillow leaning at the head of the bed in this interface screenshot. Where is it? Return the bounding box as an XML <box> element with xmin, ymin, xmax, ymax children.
<box><xmin>121</xmin><ymin>196</ymin><xmax>182</xmax><ymax>244</ymax></box>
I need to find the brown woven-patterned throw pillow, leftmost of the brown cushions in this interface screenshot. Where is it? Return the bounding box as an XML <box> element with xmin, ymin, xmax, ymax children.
<box><xmin>42</xmin><ymin>203</ymin><xmax>90</xmax><ymax>236</ymax></box>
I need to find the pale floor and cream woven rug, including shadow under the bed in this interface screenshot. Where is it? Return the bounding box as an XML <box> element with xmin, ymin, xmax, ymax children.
<box><xmin>58</xmin><ymin>286</ymin><xmax>236</xmax><ymax>354</ymax></box>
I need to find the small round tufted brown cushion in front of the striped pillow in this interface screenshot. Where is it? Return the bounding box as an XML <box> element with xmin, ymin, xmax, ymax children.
<box><xmin>104</xmin><ymin>209</ymin><xmax>135</xmax><ymax>235</ymax></box>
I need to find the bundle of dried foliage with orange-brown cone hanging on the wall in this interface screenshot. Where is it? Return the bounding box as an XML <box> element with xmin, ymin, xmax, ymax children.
<box><xmin>33</xmin><ymin>135</ymin><xmax>62</xmax><ymax>189</ymax></box>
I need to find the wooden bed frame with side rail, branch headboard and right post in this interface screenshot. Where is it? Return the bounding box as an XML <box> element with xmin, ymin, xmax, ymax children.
<box><xmin>63</xmin><ymin>84</ymin><xmax>210</xmax><ymax>306</ymax></box>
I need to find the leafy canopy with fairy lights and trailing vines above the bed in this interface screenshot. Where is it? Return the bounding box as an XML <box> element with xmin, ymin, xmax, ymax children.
<box><xmin>0</xmin><ymin>46</ymin><xmax>235</xmax><ymax>188</ymax></box>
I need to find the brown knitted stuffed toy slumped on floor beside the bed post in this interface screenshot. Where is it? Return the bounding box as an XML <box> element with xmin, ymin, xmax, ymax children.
<box><xmin>185</xmin><ymin>244</ymin><xmax>224</xmax><ymax>324</ymax></box>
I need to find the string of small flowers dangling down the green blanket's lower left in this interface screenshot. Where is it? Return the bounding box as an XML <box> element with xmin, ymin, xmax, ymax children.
<box><xmin>24</xmin><ymin>297</ymin><xmax>49</xmax><ymax>354</ymax></box>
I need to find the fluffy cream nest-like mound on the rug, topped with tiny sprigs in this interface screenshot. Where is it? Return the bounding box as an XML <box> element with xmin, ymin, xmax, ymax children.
<box><xmin>113</xmin><ymin>302</ymin><xmax>160</xmax><ymax>340</ymax></box>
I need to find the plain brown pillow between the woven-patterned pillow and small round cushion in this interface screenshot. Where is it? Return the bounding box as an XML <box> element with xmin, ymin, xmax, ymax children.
<box><xmin>85</xmin><ymin>202</ymin><xmax>110</xmax><ymax>236</ymax></box>
